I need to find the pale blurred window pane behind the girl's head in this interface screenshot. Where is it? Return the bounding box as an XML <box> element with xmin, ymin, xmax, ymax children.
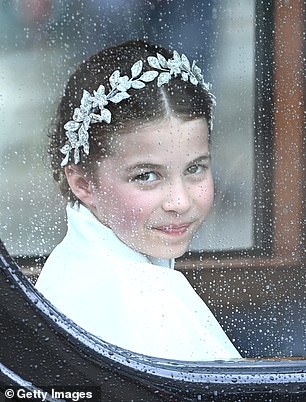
<box><xmin>0</xmin><ymin>0</ymin><xmax>256</xmax><ymax>256</ymax></box>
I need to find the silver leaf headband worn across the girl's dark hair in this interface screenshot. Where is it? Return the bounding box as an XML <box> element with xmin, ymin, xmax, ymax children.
<box><xmin>61</xmin><ymin>50</ymin><xmax>214</xmax><ymax>167</ymax></box>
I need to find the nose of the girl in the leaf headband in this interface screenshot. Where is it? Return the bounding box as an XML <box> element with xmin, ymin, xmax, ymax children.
<box><xmin>163</xmin><ymin>181</ymin><xmax>191</xmax><ymax>214</ymax></box>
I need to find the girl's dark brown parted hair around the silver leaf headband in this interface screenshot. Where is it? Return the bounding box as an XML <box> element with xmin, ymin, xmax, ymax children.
<box><xmin>49</xmin><ymin>40</ymin><xmax>214</xmax><ymax>203</ymax></box>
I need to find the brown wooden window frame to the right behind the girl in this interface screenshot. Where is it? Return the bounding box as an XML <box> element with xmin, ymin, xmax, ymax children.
<box><xmin>176</xmin><ymin>0</ymin><xmax>306</xmax><ymax>274</ymax></box>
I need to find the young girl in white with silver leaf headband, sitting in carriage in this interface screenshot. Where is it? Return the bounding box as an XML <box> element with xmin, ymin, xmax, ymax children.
<box><xmin>36</xmin><ymin>41</ymin><xmax>240</xmax><ymax>360</ymax></box>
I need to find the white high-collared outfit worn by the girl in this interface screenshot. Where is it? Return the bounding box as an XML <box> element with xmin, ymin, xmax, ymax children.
<box><xmin>36</xmin><ymin>205</ymin><xmax>240</xmax><ymax>360</ymax></box>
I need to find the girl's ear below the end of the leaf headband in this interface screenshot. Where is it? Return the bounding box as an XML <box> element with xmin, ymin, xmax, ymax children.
<box><xmin>65</xmin><ymin>165</ymin><xmax>93</xmax><ymax>208</ymax></box>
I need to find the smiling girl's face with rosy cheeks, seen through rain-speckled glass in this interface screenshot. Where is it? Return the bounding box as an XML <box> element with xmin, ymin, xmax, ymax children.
<box><xmin>91</xmin><ymin>118</ymin><xmax>214</xmax><ymax>258</ymax></box>
